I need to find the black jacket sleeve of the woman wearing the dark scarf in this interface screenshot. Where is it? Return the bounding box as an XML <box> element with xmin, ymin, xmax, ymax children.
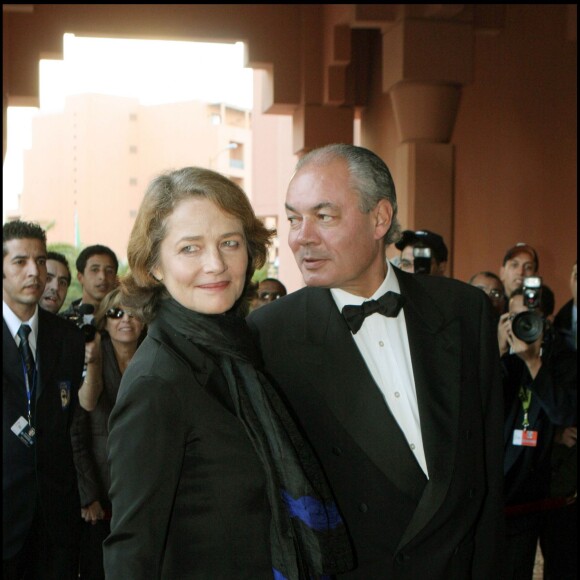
<box><xmin>104</xmin><ymin>375</ymin><xmax>186</xmax><ymax>580</ymax></box>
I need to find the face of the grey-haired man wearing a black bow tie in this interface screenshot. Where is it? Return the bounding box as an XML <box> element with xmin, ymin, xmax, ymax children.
<box><xmin>286</xmin><ymin>159</ymin><xmax>393</xmax><ymax>297</ymax></box>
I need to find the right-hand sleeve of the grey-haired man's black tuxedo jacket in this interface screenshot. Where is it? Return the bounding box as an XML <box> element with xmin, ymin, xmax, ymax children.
<box><xmin>472</xmin><ymin>301</ymin><xmax>505</xmax><ymax>580</ymax></box>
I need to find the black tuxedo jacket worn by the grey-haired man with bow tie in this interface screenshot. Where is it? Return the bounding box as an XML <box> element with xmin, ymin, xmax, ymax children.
<box><xmin>248</xmin><ymin>269</ymin><xmax>503</xmax><ymax>580</ymax></box>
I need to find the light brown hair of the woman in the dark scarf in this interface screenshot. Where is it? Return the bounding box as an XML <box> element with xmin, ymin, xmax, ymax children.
<box><xmin>121</xmin><ymin>167</ymin><xmax>275</xmax><ymax>323</ymax></box>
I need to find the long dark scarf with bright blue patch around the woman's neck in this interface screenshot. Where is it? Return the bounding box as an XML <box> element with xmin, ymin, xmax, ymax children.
<box><xmin>161</xmin><ymin>298</ymin><xmax>353</xmax><ymax>580</ymax></box>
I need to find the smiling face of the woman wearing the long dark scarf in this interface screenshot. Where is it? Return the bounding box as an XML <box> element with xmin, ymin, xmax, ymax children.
<box><xmin>152</xmin><ymin>197</ymin><xmax>248</xmax><ymax>314</ymax></box>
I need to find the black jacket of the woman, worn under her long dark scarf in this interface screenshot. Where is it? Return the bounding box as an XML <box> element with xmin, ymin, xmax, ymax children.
<box><xmin>104</xmin><ymin>316</ymin><xmax>272</xmax><ymax>580</ymax></box>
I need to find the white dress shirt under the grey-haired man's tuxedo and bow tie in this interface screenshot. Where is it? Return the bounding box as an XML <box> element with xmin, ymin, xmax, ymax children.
<box><xmin>330</xmin><ymin>265</ymin><xmax>429</xmax><ymax>477</ymax></box>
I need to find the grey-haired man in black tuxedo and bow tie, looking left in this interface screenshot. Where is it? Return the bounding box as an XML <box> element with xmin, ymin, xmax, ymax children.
<box><xmin>248</xmin><ymin>145</ymin><xmax>503</xmax><ymax>580</ymax></box>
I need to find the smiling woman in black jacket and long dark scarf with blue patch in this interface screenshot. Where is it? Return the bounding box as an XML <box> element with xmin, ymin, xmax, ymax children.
<box><xmin>104</xmin><ymin>167</ymin><xmax>352</xmax><ymax>580</ymax></box>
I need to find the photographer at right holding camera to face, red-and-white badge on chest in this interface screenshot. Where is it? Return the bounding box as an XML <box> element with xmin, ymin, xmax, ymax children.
<box><xmin>498</xmin><ymin>278</ymin><xmax>576</xmax><ymax>580</ymax></box>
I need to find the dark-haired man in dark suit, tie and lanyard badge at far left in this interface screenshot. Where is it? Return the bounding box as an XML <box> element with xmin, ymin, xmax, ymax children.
<box><xmin>2</xmin><ymin>221</ymin><xmax>84</xmax><ymax>580</ymax></box>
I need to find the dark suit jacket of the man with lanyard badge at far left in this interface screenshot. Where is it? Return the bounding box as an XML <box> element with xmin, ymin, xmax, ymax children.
<box><xmin>2</xmin><ymin>309</ymin><xmax>85</xmax><ymax>559</ymax></box>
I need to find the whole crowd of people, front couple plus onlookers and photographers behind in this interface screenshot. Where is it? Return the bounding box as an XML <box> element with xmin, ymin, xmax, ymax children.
<box><xmin>3</xmin><ymin>144</ymin><xmax>577</xmax><ymax>580</ymax></box>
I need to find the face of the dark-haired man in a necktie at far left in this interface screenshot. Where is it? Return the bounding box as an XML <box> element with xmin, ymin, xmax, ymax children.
<box><xmin>2</xmin><ymin>238</ymin><xmax>46</xmax><ymax>320</ymax></box>
